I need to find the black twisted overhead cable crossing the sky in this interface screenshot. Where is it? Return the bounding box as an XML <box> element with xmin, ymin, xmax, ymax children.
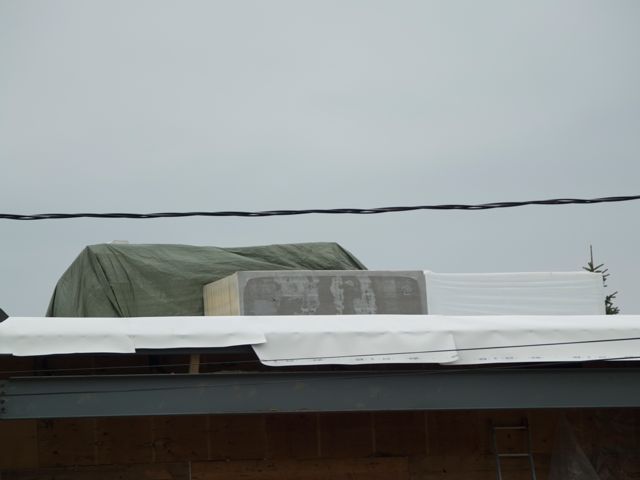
<box><xmin>0</xmin><ymin>195</ymin><xmax>640</xmax><ymax>220</ymax></box>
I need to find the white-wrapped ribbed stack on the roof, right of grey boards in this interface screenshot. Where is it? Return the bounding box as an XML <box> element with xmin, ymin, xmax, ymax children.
<box><xmin>425</xmin><ymin>271</ymin><xmax>605</xmax><ymax>315</ymax></box>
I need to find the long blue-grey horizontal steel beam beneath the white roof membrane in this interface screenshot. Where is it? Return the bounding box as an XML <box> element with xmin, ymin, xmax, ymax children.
<box><xmin>0</xmin><ymin>368</ymin><xmax>640</xmax><ymax>419</ymax></box>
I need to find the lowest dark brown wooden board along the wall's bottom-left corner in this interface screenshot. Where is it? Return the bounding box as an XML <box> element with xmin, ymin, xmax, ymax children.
<box><xmin>1</xmin><ymin>463</ymin><xmax>189</xmax><ymax>480</ymax></box>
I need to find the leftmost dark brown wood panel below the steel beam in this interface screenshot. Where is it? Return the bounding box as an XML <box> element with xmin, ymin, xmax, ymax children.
<box><xmin>0</xmin><ymin>420</ymin><xmax>38</xmax><ymax>468</ymax></box>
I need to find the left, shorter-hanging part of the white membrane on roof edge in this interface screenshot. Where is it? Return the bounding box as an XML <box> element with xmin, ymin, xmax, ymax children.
<box><xmin>0</xmin><ymin>317</ymin><xmax>265</xmax><ymax>356</ymax></box>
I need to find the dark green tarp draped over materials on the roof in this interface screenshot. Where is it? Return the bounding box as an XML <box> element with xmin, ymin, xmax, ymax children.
<box><xmin>47</xmin><ymin>243</ymin><xmax>365</xmax><ymax>317</ymax></box>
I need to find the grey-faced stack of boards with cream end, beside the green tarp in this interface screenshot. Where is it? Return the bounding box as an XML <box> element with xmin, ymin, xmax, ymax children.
<box><xmin>204</xmin><ymin>270</ymin><xmax>427</xmax><ymax>315</ymax></box>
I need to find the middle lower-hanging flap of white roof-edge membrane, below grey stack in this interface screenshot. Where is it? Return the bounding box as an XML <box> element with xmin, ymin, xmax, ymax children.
<box><xmin>244</xmin><ymin>315</ymin><xmax>458</xmax><ymax>366</ymax></box>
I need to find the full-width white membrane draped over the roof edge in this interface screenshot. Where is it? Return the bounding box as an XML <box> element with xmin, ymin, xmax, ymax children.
<box><xmin>0</xmin><ymin>315</ymin><xmax>640</xmax><ymax>366</ymax></box>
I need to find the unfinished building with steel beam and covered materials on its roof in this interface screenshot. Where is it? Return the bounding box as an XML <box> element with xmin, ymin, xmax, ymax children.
<box><xmin>0</xmin><ymin>244</ymin><xmax>640</xmax><ymax>480</ymax></box>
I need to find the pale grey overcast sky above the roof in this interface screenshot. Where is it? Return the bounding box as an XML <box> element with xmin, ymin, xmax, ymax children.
<box><xmin>0</xmin><ymin>0</ymin><xmax>640</xmax><ymax>315</ymax></box>
